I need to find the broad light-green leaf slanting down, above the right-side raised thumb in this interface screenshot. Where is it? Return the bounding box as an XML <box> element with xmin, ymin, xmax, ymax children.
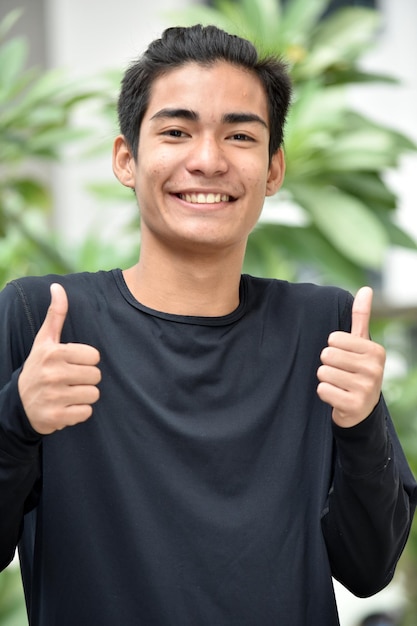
<box><xmin>293</xmin><ymin>184</ymin><xmax>388</xmax><ymax>269</ymax></box>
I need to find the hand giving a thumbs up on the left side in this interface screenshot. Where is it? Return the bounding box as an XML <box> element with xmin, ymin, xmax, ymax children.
<box><xmin>18</xmin><ymin>283</ymin><xmax>101</xmax><ymax>435</ymax></box>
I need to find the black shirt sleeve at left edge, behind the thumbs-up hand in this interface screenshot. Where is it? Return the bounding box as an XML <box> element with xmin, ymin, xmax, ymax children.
<box><xmin>0</xmin><ymin>285</ymin><xmax>42</xmax><ymax>569</ymax></box>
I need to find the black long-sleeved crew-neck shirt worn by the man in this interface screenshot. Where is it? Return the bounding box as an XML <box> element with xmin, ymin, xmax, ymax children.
<box><xmin>0</xmin><ymin>270</ymin><xmax>416</xmax><ymax>626</ymax></box>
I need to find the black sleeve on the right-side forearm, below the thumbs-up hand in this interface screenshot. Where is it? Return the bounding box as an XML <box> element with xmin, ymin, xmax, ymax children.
<box><xmin>322</xmin><ymin>397</ymin><xmax>417</xmax><ymax>597</ymax></box>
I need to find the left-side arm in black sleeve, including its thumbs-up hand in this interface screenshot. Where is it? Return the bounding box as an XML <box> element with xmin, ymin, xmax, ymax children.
<box><xmin>0</xmin><ymin>284</ymin><xmax>101</xmax><ymax>568</ymax></box>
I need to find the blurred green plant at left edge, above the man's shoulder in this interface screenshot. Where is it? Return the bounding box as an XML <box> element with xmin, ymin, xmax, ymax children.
<box><xmin>0</xmin><ymin>10</ymin><xmax>113</xmax><ymax>285</ymax></box>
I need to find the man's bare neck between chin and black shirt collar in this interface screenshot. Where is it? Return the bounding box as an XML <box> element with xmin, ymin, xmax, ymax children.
<box><xmin>123</xmin><ymin>240</ymin><xmax>243</xmax><ymax>317</ymax></box>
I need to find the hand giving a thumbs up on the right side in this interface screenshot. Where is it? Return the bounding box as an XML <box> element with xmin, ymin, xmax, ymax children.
<box><xmin>317</xmin><ymin>287</ymin><xmax>385</xmax><ymax>427</ymax></box>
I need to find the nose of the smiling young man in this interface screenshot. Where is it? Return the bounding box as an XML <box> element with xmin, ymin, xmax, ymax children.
<box><xmin>187</xmin><ymin>135</ymin><xmax>228</xmax><ymax>177</ymax></box>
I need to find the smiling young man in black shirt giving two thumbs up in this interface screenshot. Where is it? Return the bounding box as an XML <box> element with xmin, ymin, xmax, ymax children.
<box><xmin>0</xmin><ymin>26</ymin><xmax>416</xmax><ymax>626</ymax></box>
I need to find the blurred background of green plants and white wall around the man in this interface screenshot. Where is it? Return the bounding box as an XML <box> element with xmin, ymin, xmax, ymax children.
<box><xmin>0</xmin><ymin>0</ymin><xmax>417</xmax><ymax>626</ymax></box>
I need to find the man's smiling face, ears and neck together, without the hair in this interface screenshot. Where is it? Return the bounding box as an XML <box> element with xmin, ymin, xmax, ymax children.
<box><xmin>114</xmin><ymin>61</ymin><xmax>288</xmax><ymax>316</ymax></box>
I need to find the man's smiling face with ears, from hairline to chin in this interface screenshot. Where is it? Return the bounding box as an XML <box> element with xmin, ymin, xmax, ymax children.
<box><xmin>118</xmin><ymin>62</ymin><xmax>284</xmax><ymax>258</ymax></box>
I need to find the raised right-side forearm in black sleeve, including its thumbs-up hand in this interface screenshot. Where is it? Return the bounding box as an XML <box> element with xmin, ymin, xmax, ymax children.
<box><xmin>317</xmin><ymin>288</ymin><xmax>416</xmax><ymax>596</ymax></box>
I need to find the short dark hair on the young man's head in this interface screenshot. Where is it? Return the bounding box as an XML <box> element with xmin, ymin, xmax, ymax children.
<box><xmin>118</xmin><ymin>24</ymin><xmax>292</xmax><ymax>159</ymax></box>
